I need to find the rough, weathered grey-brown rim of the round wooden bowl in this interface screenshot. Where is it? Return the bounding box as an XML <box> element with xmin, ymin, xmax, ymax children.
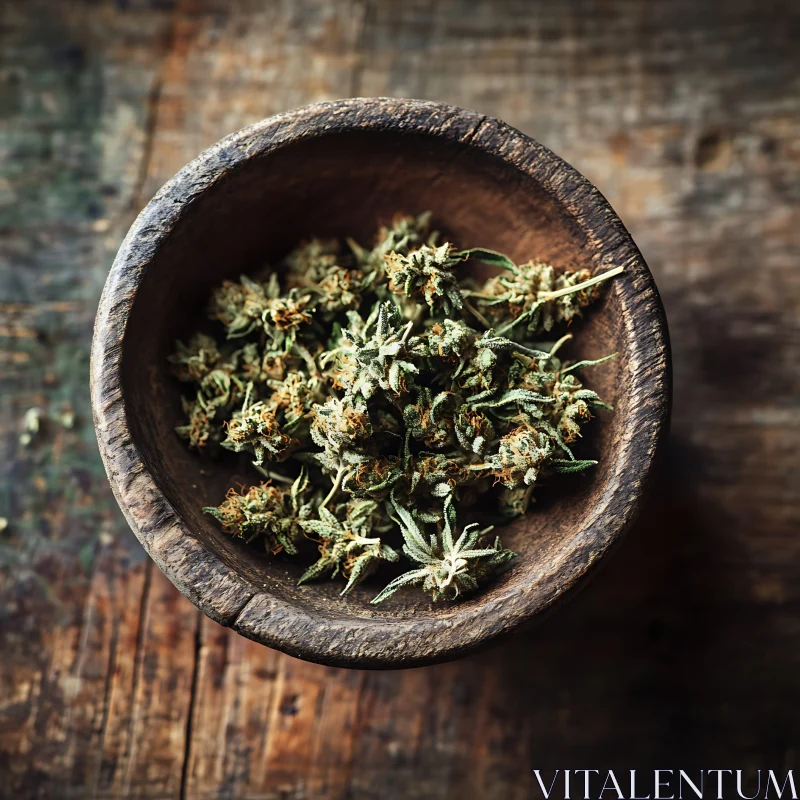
<box><xmin>91</xmin><ymin>98</ymin><xmax>670</xmax><ymax>667</ymax></box>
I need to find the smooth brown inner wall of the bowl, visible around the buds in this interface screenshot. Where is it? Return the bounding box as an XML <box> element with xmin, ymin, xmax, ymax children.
<box><xmin>122</xmin><ymin>131</ymin><xmax>629</xmax><ymax>620</ymax></box>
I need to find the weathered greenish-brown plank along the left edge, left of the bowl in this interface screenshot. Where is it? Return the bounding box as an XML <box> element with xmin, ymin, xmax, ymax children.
<box><xmin>0</xmin><ymin>3</ymin><xmax>188</xmax><ymax>797</ymax></box>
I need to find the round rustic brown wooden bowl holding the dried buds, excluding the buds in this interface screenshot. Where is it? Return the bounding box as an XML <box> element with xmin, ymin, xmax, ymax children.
<box><xmin>91</xmin><ymin>99</ymin><xmax>670</xmax><ymax>667</ymax></box>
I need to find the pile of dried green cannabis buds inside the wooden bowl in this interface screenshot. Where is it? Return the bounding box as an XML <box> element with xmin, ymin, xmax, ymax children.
<box><xmin>170</xmin><ymin>213</ymin><xmax>621</xmax><ymax>603</ymax></box>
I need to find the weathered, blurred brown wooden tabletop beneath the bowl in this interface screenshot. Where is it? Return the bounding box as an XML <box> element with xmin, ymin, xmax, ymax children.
<box><xmin>0</xmin><ymin>0</ymin><xmax>800</xmax><ymax>800</ymax></box>
